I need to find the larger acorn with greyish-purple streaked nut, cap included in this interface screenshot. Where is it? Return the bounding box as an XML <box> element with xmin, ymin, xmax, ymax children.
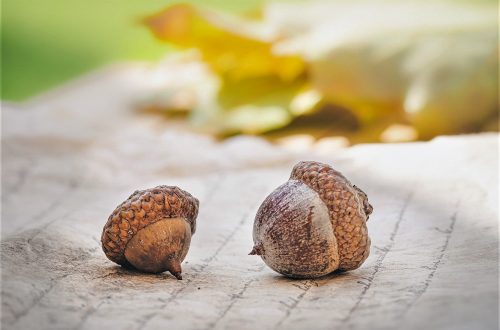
<box><xmin>250</xmin><ymin>161</ymin><xmax>373</xmax><ymax>278</ymax></box>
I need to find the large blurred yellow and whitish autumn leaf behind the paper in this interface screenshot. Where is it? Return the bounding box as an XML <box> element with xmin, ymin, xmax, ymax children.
<box><xmin>144</xmin><ymin>0</ymin><xmax>498</xmax><ymax>141</ymax></box>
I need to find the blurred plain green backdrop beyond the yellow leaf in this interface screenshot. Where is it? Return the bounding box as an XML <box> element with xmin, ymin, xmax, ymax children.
<box><xmin>1</xmin><ymin>0</ymin><xmax>263</xmax><ymax>101</ymax></box>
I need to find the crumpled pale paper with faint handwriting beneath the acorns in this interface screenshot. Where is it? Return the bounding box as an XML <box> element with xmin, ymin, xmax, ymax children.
<box><xmin>1</xmin><ymin>67</ymin><xmax>498</xmax><ymax>329</ymax></box>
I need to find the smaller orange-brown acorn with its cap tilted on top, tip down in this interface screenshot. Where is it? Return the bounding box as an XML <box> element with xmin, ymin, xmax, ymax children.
<box><xmin>101</xmin><ymin>186</ymin><xmax>199</xmax><ymax>280</ymax></box>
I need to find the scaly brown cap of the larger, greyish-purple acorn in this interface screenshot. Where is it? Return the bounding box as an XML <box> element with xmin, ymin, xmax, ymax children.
<box><xmin>290</xmin><ymin>161</ymin><xmax>373</xmax><ymax>270</ymax></box>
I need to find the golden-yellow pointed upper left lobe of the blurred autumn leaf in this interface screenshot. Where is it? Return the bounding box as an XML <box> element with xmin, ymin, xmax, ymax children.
<box><xmin>145</xmin><ymin>4</ymin><xmax>304</xmax><ymax>81</ymax></box>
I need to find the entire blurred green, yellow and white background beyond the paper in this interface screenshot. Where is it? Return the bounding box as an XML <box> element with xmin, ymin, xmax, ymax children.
<box><xmin>2</xmin><ymin>0</ymin><xmax>499</xmax><ymax>144</ymax></box>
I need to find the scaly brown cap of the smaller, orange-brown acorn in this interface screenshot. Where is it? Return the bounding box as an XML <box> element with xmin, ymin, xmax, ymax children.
<box><xmin>101</xmin><ymin>186</ymin><xmax>199</xmax><ymax>266</ymax></box>
